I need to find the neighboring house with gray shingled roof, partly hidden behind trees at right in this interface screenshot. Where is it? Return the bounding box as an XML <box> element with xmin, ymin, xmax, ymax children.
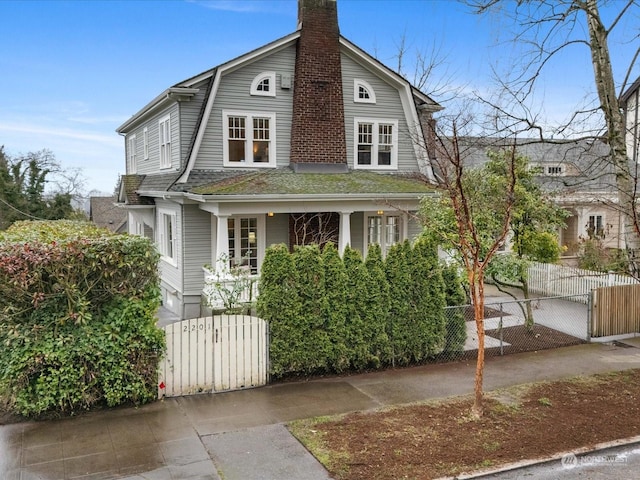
<box><xmin>462</xmin><ymin>138</ymin><xmax>624</xmax><ymax>261</ymax></box>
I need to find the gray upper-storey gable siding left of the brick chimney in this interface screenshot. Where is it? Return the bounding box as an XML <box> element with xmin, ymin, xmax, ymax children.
<box><xmin>195</xmin><ymin>46</ymin><xmax>295</xmax><ymax>169</ymax></box>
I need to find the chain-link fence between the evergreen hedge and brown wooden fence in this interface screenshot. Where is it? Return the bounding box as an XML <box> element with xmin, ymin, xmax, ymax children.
<box><xmin>436</xmin><ymin>294</ymin><xmax>589</xmax><ymax>362</ymax></box>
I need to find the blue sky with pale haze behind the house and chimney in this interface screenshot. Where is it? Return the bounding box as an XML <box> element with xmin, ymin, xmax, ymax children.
<box><xmin>0</xmin><ymin>0</ymin><xmax>638</xmax><ymax>193</ymax></box>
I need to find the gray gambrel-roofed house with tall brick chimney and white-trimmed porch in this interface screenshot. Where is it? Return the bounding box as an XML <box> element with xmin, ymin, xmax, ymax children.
<box><xmin>117</xmin><ymin>0</ymin><xmax>441</xmax><ymax>318</ymax></box>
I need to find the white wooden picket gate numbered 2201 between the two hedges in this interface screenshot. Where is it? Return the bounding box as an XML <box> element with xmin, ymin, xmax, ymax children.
<box><xmin>158</xmin><ymin>315</ymin><xmax>269</xmax><ymax>398</ymax></box>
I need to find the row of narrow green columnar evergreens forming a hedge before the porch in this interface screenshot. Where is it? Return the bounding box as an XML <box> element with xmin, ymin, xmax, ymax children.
<box><xmin>257</xmin><ymin>238</ymin><xmax>466</xmax><ymax>377</ymax></box>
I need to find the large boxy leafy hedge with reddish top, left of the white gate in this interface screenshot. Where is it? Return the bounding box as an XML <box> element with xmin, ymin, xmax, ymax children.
<box><xmin>0</xmin><ymin>221</ymin><xmax>164</xmax><ymax>416</ymax></box>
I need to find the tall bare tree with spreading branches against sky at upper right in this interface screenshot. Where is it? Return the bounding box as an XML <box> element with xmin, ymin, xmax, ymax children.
<box><xmin>466</xmin><ymin>0</ymin><xmax>640</xmax><ymax>276</ymax></box>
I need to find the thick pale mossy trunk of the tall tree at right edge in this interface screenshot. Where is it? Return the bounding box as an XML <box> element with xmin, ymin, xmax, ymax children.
<box><xmin>583</xmin><ymin>0</ymin><xmax>640</xmax><ymax>277</ymax></box>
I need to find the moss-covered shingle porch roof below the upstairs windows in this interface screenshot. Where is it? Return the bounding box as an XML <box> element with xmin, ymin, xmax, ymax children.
<box><xmin>191</xmin><ymin>169</ymin><xmax>434</xmax><ymax>195</ymax></box>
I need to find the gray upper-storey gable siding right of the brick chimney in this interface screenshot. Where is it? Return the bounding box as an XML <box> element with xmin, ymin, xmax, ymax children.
<box><xmin>342</xmin><ymin>54</ymin><xmax>420</xmax><ymax>171</ymax></box>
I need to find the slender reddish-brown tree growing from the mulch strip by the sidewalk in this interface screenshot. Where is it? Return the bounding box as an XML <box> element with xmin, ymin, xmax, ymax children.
<box><xmin>420</xmin><ymin>117</ymin><xmax>517</xmax><ymax>417</ymax></box>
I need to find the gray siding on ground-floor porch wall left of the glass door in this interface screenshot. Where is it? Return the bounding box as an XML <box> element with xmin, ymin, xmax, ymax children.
<box><xmin>182</xmin><ymin>205</ymin><xmax>212</xmax><ymax>295</ymax></box>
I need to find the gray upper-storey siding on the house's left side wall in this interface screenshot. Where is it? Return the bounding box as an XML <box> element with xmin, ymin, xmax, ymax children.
<box><xmin>126</xmin><ymin>103</ymin><xmax>181</xmax><ymax>175</ymax></box>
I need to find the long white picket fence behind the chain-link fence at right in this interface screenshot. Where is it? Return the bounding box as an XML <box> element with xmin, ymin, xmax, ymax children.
<box><xmin>528</xmin><ymin>263</ymin><xmax>638</xmax><ymax>298</ymax></box>
